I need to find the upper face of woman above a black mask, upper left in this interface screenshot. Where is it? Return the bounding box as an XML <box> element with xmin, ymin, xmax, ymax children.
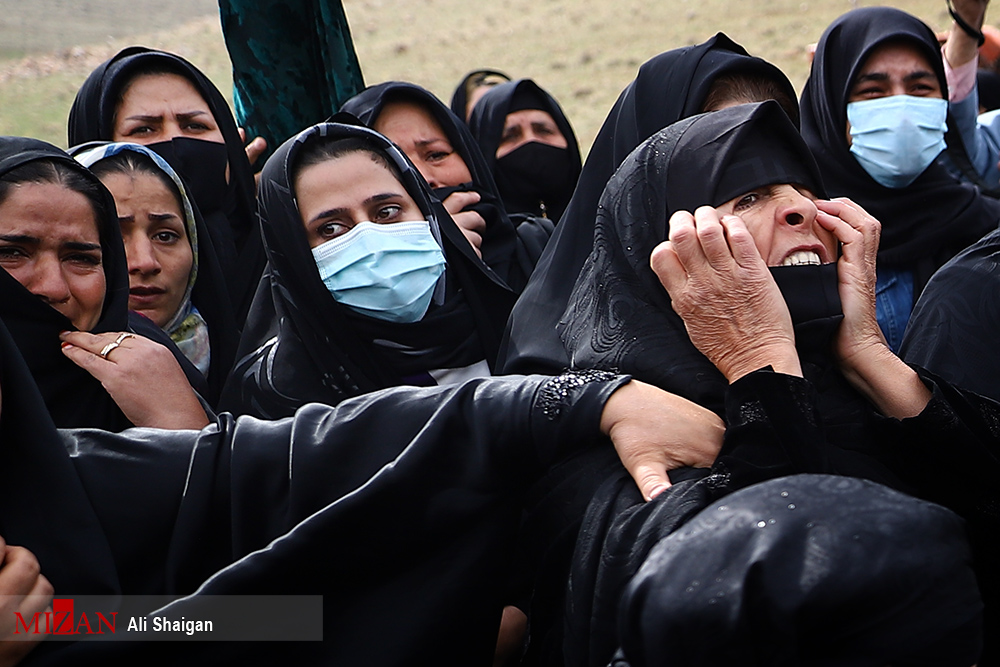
<box><xmin>111</xmin><ymin>74</ymin><xmax>225</xmax><ymax>145</ymax></box>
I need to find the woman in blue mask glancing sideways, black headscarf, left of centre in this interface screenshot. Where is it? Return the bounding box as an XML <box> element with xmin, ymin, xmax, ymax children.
<box><xmin>222</xmin><ymin>123</ymin><xmax>514</xmax><ymax>419</ymax></box>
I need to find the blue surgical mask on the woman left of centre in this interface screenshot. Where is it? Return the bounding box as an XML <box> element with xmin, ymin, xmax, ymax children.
<box><xmin>312</xmin><ymin>220</ymin><xmax>445</xmax><ymax>323</ymax></box>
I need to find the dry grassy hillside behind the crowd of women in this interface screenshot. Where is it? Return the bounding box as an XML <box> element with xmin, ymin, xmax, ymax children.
<box><xmin>0</xmin><ymin>0</ymin><xmax>952</xmax><ymax>152</ymax></box>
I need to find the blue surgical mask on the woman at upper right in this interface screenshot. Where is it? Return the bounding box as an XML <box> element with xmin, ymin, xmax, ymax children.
<box><xmin>847</xmin><ymin>95</ymin><xmax>948</xmax><ymax>188</ymax></box>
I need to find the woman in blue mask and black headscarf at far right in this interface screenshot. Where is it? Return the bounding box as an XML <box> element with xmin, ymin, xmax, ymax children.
<box><xmin>802</xmin><ymin>7</ymin><xmax>1000</xmax><ymax>350</ymax></box>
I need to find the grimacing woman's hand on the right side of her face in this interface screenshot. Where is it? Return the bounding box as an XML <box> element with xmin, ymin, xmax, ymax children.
<box><xmin>816</xmin><ymin>197</ymin><xmax>888</xmax><ymax>366</ymax></box>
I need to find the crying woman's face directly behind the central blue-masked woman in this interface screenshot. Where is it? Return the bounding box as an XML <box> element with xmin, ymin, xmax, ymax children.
<box><xmin>374</xmin><ymin>102</ymin><xmax>472</xmax><ymax>188</ymax></box>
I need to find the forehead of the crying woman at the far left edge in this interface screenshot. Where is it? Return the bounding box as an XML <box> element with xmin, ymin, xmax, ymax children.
<box><xmin>0</xmin><ymin>183</ymin><xmax>100</xmax><ymax>243</ymax></box>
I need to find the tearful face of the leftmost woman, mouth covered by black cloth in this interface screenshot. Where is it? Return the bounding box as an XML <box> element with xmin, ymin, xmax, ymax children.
<box><xmin>0</xmin><ymin>183</ymin><xmax>106</xmax><ymax>331</ymax></box>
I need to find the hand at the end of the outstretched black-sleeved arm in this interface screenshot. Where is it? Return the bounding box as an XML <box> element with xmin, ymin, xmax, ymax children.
<box><xmin>601</xmin><ymin>380</ymin><xmax>726</xmax><ymax>500</ymax></box>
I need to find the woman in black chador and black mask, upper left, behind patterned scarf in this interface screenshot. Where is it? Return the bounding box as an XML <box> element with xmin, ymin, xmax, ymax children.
<box><xmin>69</xmin><ymin>46</ymin><xmax>266</xmax><ymax>324</ymax></box>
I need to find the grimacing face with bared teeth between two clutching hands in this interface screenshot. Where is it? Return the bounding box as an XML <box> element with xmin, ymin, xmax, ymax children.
<box><xmin>715</xmin><ymin>183</ymin><xmax>837</xmax><ymax>266</ymax></box>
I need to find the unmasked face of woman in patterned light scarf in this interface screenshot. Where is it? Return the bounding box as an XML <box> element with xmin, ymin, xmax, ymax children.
<box><xmin>101</xmin><ymin>172</ymin><xmax>194</xmax><ymax>327</ymax></box>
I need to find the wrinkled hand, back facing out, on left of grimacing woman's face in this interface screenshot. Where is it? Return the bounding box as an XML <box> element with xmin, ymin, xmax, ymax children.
<box><xmin>650</xmin><ymin>206</ymin><xmax>802</xmax><ymax>382</ymax></box>
